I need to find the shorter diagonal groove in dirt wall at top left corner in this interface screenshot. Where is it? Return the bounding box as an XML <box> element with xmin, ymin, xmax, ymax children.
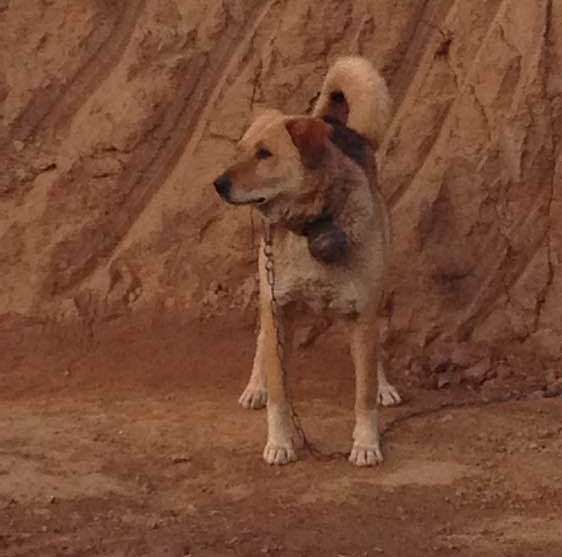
<box><xmin>10</xmin><ymin>0</ymin><xmax>145</xmax><ymax>141</ymax></box>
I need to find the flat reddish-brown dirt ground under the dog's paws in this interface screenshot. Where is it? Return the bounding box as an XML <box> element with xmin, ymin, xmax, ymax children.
<box><xmin>0</xmin><ymin>318</ymin><xmax>562</xmax><ymax>557</ymax></box>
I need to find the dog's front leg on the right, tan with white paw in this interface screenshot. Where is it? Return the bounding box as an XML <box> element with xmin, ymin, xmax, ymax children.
<box><xmin>349</xmin><ymin>314</ymin><xmax>382</xmax><ymax>466</ymax></box>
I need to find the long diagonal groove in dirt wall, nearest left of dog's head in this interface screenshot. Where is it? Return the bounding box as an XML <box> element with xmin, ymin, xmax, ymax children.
<box><xmin>43</xmin><ymin>0</ymin><xmax>278</xmax><ymax>295</ymax></box>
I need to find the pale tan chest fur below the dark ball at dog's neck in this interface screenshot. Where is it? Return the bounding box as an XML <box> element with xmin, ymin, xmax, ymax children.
<box><xmin>274</xmin><ymin>235</ymin><xmax>367</xmax><ymax>315</ymax></box>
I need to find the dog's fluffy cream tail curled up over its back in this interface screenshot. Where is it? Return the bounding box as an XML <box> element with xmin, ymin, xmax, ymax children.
<box><xmin>313</xmin><ymin>56</ymin><xmax>392</xmax><ymax>145</ymax></box>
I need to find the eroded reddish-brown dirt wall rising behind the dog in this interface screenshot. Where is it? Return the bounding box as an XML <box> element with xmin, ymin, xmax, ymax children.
<box><xmin>0</xmin><ymin>0</ymin><xmax>562</xmax><ymax>365</ymax></box>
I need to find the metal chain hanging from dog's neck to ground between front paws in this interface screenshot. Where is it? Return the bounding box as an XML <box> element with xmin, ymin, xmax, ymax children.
<box><xmin>263</xmin><ymin>222</ymin><xmax>349</xmax><ymax>460</ymax></box>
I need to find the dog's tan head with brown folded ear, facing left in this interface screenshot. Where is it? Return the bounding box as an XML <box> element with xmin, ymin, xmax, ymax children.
<box><xmin>214</xmin><ymin>111</ymin><xmax>332</xmax><ymax>218</ymax></box>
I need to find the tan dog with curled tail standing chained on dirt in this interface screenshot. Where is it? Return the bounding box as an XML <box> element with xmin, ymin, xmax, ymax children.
<box><xmin>214</xmin><ymin>56</ymin><xmax>400</xmax><ymax>466</ymax></box>
